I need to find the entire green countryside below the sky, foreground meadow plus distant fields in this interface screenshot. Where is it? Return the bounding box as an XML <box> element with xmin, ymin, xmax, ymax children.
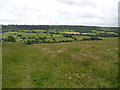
<box><xmin>2</xmin><ymin>26</ymin><xmax>119</xmax><ymax>88</ymax></box>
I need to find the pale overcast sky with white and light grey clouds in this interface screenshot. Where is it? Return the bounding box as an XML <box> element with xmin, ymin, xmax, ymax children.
<box><xmin>0</xmin><ymin>0</ymin><xmax>119</xmax><ymax>26</ymax></box>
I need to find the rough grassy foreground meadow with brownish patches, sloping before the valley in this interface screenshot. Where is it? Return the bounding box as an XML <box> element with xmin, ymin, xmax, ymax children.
<box><xmin>2</xmin><ymin>39</ymin><xmax>118</xmax><ymax>88</ymax></box>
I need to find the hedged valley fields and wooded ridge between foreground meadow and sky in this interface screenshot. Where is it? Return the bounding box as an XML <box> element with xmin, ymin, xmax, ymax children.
<box><xmin>2</xmin><ymin>25</ymin><xmax>119</xmax><ymax>44</ymax></box>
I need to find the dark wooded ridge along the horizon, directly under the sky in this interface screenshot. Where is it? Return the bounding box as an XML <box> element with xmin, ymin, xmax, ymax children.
<box><xmin>2</xmin><ymin>25</ymin><xmax>118</xmax><ymax>33</ymax></box>
